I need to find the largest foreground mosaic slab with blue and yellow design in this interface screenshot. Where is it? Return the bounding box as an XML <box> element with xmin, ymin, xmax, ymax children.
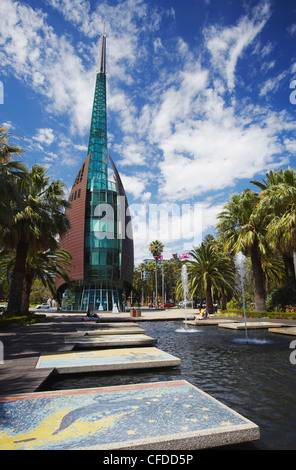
<box><xmin>0</xmin><ymin>380</ymin><xmax>260</xmax><ymax>450</ymax></box>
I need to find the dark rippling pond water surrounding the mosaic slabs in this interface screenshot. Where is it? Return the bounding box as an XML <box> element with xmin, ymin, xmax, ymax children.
<box><xmin>43</xmin><ymin>321</ymin><xmax>296</xmax><ymax>450</ymax></box>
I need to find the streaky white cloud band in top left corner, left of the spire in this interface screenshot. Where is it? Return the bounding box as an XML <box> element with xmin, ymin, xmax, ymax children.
<box><xmin>0</xmin><ymin>0</ymin><xmax>94</xmax><ymax>134</ymax></box>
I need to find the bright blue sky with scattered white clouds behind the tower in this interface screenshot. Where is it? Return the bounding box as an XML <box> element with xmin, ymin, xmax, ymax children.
<box><xmin>0</xmin><ymin>0</ymin><xmax>296</xmax><ymax>263</ymax></box>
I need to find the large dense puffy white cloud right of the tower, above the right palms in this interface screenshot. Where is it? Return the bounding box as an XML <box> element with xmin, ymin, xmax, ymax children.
<box><xmin>159</xmin><ymin>117</ymin><xmax>281</xmax><ymax>200</ymax></box>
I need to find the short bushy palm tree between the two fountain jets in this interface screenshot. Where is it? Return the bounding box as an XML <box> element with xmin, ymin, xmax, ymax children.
<box><xmin>179</xmin><ymin>240</ymin><xmax>235</xmax><ymax>313</ymax></box>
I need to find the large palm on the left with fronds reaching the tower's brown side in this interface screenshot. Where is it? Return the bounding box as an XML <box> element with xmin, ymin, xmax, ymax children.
<box><xmin>0</xmin><ymin>165</ymin><xmax>70</xmax><ymax>316</ymax></box>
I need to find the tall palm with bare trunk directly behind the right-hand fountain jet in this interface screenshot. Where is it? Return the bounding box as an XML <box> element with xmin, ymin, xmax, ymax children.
<box><xmin>216</xmin><ymin>189</ymin><xmax>267</xmax><ymax>312</ymax></box>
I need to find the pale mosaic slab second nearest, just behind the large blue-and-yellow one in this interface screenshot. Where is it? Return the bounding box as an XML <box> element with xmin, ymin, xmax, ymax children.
<box><xmin>36</xmin><ymin>347</ymin><xmax>181</xmax><ymax>374</ymax></box>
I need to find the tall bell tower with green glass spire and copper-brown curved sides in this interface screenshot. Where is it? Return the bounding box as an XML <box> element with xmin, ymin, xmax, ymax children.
<box><xmin>57</xmin><ymin>28</ymin><xmax>134</xmax><ymax>311</ymax></box>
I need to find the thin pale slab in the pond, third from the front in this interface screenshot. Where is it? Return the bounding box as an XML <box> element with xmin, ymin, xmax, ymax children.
<box><xmin>65</xmin><ymin>335</ymin><xmax>157</xmax><ymax>348</ymax></box>
